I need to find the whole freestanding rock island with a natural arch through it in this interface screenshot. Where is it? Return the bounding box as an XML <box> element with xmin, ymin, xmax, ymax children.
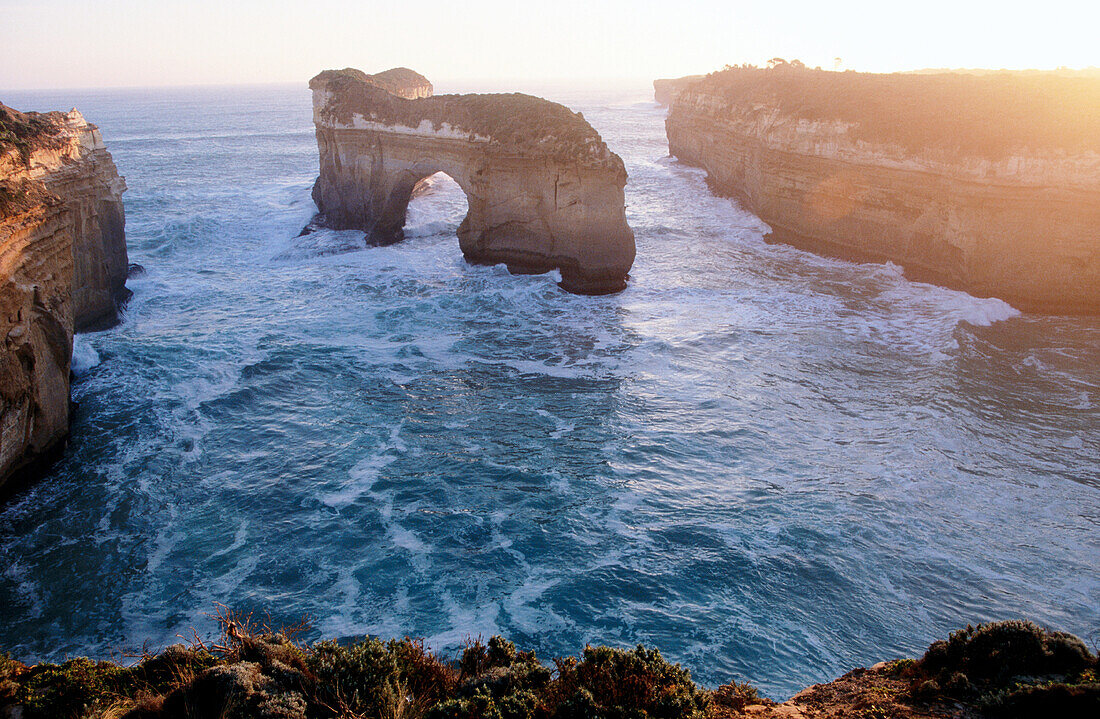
<box><xmin>309</xmin><ymin>65</ymin><xmax>635</xmax><ymax>295</ymax></box>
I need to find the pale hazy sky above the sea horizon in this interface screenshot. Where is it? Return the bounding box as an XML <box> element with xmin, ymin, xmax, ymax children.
<box><xmin>0</xmin><ymin>0</ymin><xmax>1100</xmax><ymax>89</ymax></box>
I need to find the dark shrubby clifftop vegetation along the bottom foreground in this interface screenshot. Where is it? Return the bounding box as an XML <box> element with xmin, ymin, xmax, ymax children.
<box><xmin>0</xmin><ymin>611</ymin><xmax>1100</xmax><ymax>719</ymax></box>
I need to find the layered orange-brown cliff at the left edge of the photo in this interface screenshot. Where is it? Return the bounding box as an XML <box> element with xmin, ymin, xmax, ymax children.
<box><xmin>0</xmin><ymin>104</ymin><xmax>127</xmax><ymax>485</ymax></box>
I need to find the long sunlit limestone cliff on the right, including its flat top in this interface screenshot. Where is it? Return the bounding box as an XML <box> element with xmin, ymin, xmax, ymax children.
<box><xmin>666</xmin><ymin>67</ymin><xmax>1100</xmax><ymax>314</ymax></box>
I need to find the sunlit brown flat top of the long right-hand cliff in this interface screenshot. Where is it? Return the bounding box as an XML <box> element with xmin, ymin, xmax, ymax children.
<box><xmin>688</xmin><ymin>65</ymin><xmax>1100</xmax><ymax>159</ymax></box>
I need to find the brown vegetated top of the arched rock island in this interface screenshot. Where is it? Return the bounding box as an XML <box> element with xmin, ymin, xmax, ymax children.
<box><xmin>309</xmin><ymin>70</ymin><xmax>625</xmax><ymax>169</ymax></box>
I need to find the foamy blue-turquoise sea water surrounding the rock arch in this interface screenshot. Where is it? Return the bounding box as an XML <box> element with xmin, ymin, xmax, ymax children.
<box><xmin>0</xmin><ymin>87</ymin><xmax>1100</xmax><ymax>696</ymax></box>
